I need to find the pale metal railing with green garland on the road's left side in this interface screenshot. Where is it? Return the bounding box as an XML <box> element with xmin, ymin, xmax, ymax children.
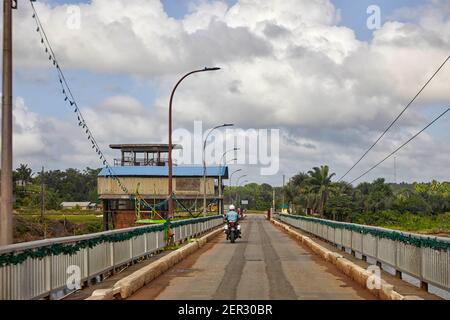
<box><xmin>0</xmin><ymin>216</ymin><xmax>223</xmax><ymax>300</ymax></box>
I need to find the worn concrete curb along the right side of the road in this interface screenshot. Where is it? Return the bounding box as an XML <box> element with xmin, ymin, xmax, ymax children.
<box><xmin>270</xmin><ymin>219</ymin><xmax>408</xmax><ymax>300</ymax></box>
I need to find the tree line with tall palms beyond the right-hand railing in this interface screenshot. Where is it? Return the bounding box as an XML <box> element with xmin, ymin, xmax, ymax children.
<box><xmin>225</xmin><ymin>165</ymin><xmax>450</xmax><ymax>223</ymax></box>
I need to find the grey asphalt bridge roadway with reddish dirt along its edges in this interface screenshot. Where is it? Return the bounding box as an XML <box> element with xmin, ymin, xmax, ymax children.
<box><xmin>129</xmin><ymin>215</ymin><xmax>374</xmax><ymax>300</ymax></box>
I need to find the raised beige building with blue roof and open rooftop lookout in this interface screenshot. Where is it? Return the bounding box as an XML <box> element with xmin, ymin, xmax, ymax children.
<box><xmin>97</xmin><ymin>144</ymin><xmax>228</xmax><ymax>230</ymax></box>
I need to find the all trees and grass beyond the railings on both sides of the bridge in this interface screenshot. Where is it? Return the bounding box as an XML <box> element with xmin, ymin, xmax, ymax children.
<box><xmin>14</xmin><ymin>164</ymin><xmax>450</xmax><ymax>238</ymax></box>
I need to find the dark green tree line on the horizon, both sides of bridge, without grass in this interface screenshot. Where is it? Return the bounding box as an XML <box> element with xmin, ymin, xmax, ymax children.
<box><xmin>13</xmin><ymin>164</ymin><xmax>450</xmax><ymax>228</ymax></box>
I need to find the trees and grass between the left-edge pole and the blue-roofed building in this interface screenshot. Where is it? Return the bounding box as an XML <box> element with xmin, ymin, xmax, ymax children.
<box><xmin>13</xmin><ymin>164</ymin><xmax>102</xmax><ymax>242</ymax></box>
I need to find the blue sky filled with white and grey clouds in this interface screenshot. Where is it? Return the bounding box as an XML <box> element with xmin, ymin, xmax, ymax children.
<box><xmin>0</xmin><ymin>0</ymin><xmax>450</xmax><ymax>185</ymax></box>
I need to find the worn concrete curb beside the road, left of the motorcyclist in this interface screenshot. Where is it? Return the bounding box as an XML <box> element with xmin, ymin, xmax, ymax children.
<box><xmin>85</xmin><ymin>228</ymin><xmax>223</xmax><ymax>300</ymax></box>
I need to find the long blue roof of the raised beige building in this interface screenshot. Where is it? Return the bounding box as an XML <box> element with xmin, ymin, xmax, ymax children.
<box><xmin>98</xmin><ymin>166</ymin><xmax>228</xmax><ymax>178</ymax></box>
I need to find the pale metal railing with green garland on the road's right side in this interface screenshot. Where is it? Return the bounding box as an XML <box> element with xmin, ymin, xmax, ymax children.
<box><xmin>274</xmin><ymin>214</ymin><xmax>450</xmax><ymax>291</ymax></box>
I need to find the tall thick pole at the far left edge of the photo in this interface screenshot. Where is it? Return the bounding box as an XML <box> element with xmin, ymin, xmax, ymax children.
<box><xmin>0</xmin><ymin>0</ymin><xmax>13</xmax><ymax>246</ymax></box>
